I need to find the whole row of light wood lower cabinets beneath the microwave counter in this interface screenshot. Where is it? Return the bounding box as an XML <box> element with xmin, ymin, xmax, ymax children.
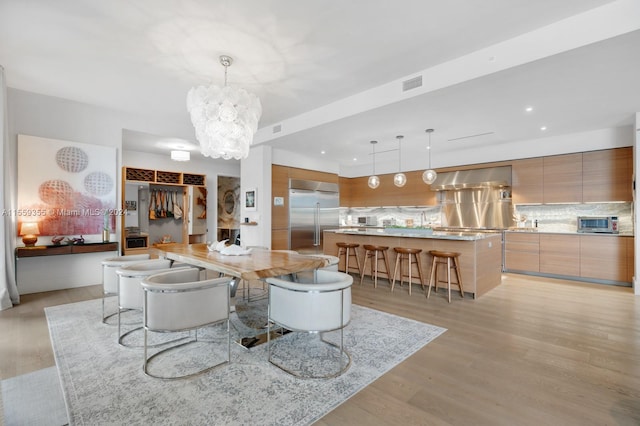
<box><xmin>504</xmin><ymin>232</ymin><xmax>634</xmax><ymax>283</ymax></box>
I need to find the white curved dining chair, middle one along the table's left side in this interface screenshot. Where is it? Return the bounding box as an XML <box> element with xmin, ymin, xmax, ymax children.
<box><xmin>116</xmin><ymin>259</ymin><xmax>188</xmax><ymax>347</ymax></box>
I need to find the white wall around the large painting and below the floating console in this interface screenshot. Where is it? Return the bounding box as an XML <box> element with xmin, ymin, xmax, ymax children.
<box><xmin>5</xmin><ymin>88</ymin><xmax>214</xmax><ymax>294</ymax></box>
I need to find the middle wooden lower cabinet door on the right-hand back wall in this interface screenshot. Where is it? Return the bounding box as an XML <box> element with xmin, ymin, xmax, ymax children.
<box><xmin>540</xmin><ymin>234</ymin><xmax>580</xmax><ymax>277</ymax></box>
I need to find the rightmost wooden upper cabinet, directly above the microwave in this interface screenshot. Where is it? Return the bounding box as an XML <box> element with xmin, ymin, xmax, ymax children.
<box><xmin>582</xmin><ymin>147</ymin><xmax>633</xmax><ymax>203</ymax></box>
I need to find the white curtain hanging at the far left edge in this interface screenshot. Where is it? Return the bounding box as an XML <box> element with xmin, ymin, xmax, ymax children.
<box><xmin>0</xmin><ymin>65</ymin><xmax>20</xmax><ymax>310</ymax></box>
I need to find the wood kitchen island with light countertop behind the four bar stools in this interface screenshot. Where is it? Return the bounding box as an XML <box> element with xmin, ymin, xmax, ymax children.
<box><xmin>323</xmin><ymin>228</ymin><xmax>502</xmax><ymax>298</ymax></box>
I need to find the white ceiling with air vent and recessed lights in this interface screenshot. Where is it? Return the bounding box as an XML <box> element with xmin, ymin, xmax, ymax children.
<box><xmin>0</xmin><ymin>0</ymin><xmax>640</xmax><ymax>173</ymax></box>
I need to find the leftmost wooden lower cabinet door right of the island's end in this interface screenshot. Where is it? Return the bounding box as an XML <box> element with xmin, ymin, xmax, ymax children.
<box><xmin>504</xmin><ymin>232</ymin><xmax>540</xmax><ymax>272</ymax></box>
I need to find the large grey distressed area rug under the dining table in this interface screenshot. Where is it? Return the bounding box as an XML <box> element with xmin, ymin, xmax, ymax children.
<box><xmin>45</xmin><ymin>300</ymin><xmax>445</xmax><ymax>425</ymax></box>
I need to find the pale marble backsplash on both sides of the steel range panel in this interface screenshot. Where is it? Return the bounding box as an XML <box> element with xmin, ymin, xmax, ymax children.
<box><xmin>340</xmin><ymin>203</ymin><xmax>633</xmax><ymax>235</ymax></box>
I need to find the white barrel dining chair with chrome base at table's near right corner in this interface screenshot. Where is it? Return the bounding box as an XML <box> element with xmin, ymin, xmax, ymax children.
<box><xmin>266</xmin><ymin>269</ymin><xmax>353</xmax><ymax>378</ymax></box>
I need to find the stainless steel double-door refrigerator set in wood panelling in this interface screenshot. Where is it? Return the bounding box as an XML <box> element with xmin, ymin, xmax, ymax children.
<box><xmin>289</xmin><ymin>179</ymin><xmax>340</xmax><ymax>253</ymax></box>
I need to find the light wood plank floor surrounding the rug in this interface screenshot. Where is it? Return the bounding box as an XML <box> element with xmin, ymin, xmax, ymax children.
<box><xmin>0</xmin><ymin>274</ymin><xmax>640</xmax><ymax>426</ymax></box>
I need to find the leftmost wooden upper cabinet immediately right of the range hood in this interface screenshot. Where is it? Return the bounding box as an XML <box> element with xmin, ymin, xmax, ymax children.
<box><xmin>511</xmin><ymin>157</ymin><xmax>543</xmax><ymax>204</ymax></box>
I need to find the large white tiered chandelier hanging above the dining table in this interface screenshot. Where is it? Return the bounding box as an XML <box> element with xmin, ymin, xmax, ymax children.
<box><xmin>187</xmin><ymin>55</ymin><xmax>262</xmax><ymax>160</ymax></box>
